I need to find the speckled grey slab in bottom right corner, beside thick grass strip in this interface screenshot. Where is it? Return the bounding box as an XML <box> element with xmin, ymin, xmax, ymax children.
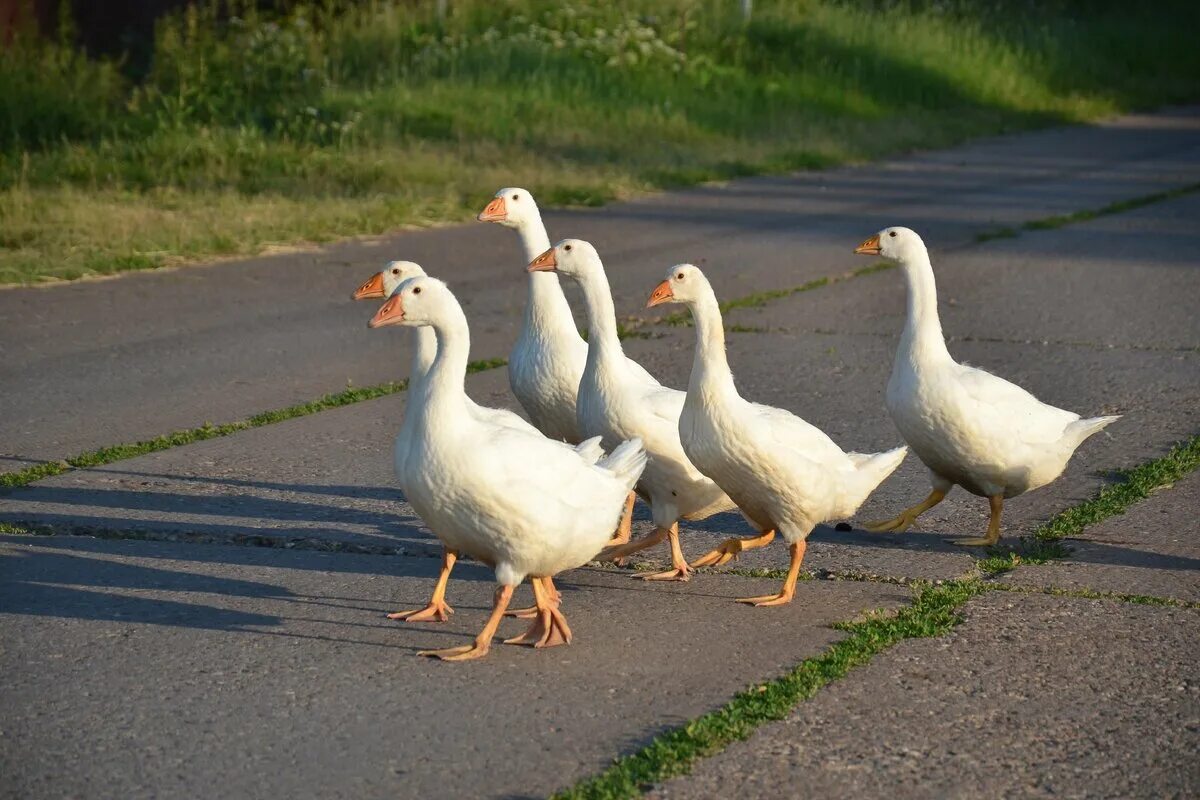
<box><xmin>650</xmin><ymin>591</ymin><xmax>1200</xmax><ymax>799</ymax></box>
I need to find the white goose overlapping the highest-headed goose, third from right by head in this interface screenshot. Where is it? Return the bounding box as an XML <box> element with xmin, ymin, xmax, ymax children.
<box><xmin>529</xmin><ymin>239</ymin><xmax>733</xmax><ymax>581</ymax></box>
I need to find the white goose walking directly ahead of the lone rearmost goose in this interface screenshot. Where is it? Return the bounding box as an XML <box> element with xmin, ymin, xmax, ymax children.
<box><xmin>647</xmin><ymin>264</ymin><xmax>907</xmax><ymax>606</ymax></box>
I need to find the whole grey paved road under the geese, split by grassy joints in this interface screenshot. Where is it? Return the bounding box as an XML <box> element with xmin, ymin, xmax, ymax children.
<box><xmin>0</xmin><ymin>109</ymin><xmax>1200</xmax><ymax>799</ymax></box>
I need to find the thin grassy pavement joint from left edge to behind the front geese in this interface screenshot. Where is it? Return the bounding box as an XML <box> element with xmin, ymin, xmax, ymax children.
<box><xmin>0</xmin><ymin>359</ymin><xmax>508</xmax><ymax>492</ymax></box>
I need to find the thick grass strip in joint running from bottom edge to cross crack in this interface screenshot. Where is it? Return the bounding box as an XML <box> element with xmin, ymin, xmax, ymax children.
<box><xmin>554</xmin><ymin>581</ymin><xmax>985</xmax><ymax>800</ymax></box>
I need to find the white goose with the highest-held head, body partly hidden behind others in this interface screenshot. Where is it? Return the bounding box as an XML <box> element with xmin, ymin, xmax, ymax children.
<box><xmin>478</xmin><ymin>187</ymin><xmax>649</xmax><ymax>545</ymax></box>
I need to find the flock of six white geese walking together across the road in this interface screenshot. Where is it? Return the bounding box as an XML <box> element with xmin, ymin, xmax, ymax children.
<box><xmin>354</xmin><ymin>188</ymin><xmax>1118</xmax><ymax>661</ymax></box>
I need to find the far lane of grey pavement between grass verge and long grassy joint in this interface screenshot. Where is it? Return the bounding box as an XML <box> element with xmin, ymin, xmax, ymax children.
<box><xmin>0</xmin><ymin>108</ymin><xmax>1200</xmax><ymax>459</ymax></box>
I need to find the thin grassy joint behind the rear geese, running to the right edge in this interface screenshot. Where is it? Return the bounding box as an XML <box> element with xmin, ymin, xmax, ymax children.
<box><xmin>655</xmin><ymin>184</ymin><xmax>1200</xmax><ymax>333</ymax></box>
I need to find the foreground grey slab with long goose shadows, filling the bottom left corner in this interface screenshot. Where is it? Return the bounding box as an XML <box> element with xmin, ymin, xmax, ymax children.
<box><xmin>0</xmin><ymin>537</ymin><xmax>910</xmax><ymax>800</ymax></box>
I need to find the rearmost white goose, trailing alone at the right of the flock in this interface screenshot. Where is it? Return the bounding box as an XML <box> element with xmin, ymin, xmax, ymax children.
<box><xmin>854</xmin><ymin>228</ymin><xmax>1120</xmax><ymax>546</ymax></box>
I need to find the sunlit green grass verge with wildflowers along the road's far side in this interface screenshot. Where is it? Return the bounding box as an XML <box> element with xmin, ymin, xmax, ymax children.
<box><xmin>0</xmin><ymin>0</ymin><xmax>1200</xmax><ymax>283</ymax></box>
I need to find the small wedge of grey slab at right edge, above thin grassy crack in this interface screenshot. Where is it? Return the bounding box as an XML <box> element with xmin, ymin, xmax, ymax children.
<box><xmin>1000</xmin><ymin>473</ymin><xmax>1200</xmax><ymax>602</ymax></box>
